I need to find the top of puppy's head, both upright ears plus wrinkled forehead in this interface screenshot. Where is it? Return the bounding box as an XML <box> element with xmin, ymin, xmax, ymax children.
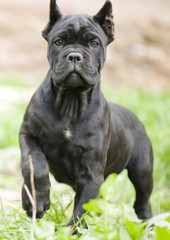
<box><xmin>42</xmin><ymin>0</ymin><xmax>114</xmax><ymax>45</ymax></box>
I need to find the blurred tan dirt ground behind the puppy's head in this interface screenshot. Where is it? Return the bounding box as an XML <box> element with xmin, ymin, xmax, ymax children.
<box><xmin>0</xmin><ymin>0</ymin><xmax>170</xmax><ymax>90</ymax></box>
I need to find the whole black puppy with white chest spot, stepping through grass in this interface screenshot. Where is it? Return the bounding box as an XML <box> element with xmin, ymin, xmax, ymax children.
<box><xmin>20</xmin><ymin>0</ymin><xmax>153</xmax><ymax>225</ymax></box>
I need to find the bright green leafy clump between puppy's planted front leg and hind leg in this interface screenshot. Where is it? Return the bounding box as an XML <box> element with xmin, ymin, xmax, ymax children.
<box><xmin>84</xmin><ymin>174</ymin><xmax>146</xmax><ymax>240</ymax></box>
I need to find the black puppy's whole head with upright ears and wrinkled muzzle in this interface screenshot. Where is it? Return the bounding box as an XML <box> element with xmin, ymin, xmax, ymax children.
<box><xmin>43</xmin><ymin>0</ymin><xmax>114</xmax><ymax>90</ymax></box>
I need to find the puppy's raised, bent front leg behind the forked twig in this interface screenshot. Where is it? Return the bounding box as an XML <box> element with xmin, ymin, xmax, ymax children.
<box><xmin>19</xmin><ymin>134</ymin><xmax>50</xmax><ymax>218</ymax></box>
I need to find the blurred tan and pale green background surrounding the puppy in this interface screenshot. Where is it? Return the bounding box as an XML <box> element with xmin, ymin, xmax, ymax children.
<box><xmin>0</xmin><ymin>0</ymin><xmax>170</xmax><ymax>212</ymax></box>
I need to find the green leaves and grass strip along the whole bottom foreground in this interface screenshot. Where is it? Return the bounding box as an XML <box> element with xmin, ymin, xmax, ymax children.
<box><xmin>0</xmin><ymin>174</ymin><xmax>170</xmax><ymax>240</ymax></box>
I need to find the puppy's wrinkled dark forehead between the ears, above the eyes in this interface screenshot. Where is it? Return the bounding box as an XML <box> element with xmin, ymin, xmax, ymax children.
<box><xmin>49</xmin><ymin>14</ymin><xmax>106</xmax><ymax>41</ymax></box>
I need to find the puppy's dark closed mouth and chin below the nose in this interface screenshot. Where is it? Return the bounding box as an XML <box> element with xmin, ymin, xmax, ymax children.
<box><xmin>55</xmin><ymin>71</ymin><xmax>92</xmax><ymax>91</ymax></box>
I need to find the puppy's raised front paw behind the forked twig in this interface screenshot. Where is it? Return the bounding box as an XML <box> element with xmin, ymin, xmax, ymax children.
<box><xmin>22</xmin><ymin>187</ymin><xmax>50</xmax><ymax>218</ymax></box>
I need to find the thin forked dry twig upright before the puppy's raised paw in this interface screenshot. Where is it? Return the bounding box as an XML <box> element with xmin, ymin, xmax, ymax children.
<box><xmin>24</xmin><ymin>156</ymin><xmax>37</xmax><ymax>240</ymax></box>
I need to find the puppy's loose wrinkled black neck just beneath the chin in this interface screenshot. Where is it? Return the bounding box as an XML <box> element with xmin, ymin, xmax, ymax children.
<box><xmin>52</xmin><ymin>82</ymin><xmax>100</xmax><ymax>123</ymax></box>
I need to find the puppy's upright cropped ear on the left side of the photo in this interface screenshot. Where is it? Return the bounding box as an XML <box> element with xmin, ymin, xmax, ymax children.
<box><xmin>42</xmin><ymin>0</ymin><xmax>63</xmax><ymax>40</ymax></box>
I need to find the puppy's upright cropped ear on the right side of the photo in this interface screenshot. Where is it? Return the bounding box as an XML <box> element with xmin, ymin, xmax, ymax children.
<box><xmin>93</xmin><ymin>0</ymin><xmax>114</xmax><ymax>44</ymax></box>
